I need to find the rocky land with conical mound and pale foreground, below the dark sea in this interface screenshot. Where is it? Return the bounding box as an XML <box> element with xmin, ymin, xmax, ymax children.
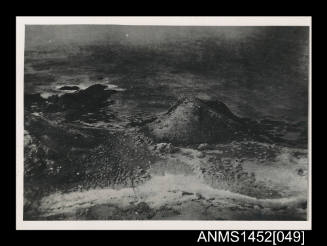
<box><xmin>24</xmin><ymin>84</ymin><xmax>307</xmax><ymax>220</ymax></box>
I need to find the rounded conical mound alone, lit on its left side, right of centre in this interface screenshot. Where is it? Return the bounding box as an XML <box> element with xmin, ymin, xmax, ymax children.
<box><xmin>147</xmin><ymin>97</ymin><xmax>249</xmax><ymax>144</ymax></box>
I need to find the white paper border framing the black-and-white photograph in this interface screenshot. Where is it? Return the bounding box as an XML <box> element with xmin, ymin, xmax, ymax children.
<box><xmin>16</xmin><ymin>16</ymin><xmax>312</xmax><ymax>230</ymax></box>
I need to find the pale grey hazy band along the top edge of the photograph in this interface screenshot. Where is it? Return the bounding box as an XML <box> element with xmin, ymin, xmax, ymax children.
<box><xmin>26</xmin><ymin>25</ymin><xmax>288</xmax><ymax>48</ymax></box>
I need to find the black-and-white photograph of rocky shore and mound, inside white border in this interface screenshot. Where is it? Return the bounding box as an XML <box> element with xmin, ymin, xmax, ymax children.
<box><xmin>16</xmin><ymin>17</ymin><xmax>311</xmax><ymax>230</ymax></box>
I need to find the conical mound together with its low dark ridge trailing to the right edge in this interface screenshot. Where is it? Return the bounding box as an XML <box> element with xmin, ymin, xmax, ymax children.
<box><xmin>145</xmin><ymin>97</ymin><xmax>307</xmax><ymax>147</ymax></box>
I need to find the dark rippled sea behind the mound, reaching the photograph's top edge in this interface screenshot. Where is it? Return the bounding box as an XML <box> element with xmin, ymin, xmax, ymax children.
<box><xmin>25</xmin><ymin>26</ymin><xmax>309</xmax><ymax>121</ymax></box>
